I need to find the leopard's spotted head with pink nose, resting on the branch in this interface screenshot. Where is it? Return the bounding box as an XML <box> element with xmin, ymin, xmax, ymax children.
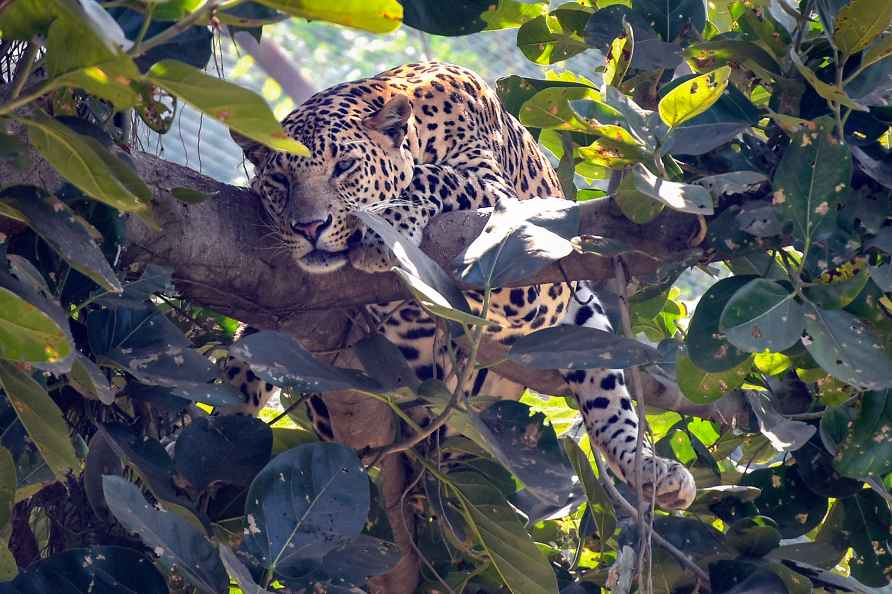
<box><xmin>232</xmin><ymin>93</ymin><xmax>414</xmax><ymax>274</ymax></box>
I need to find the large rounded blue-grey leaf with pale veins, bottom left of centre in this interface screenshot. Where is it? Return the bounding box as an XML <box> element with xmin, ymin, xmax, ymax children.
<box><xmin>245</xmin><ymin>443</ymin><xmax>369</xmax><ymax>579</ymax></box>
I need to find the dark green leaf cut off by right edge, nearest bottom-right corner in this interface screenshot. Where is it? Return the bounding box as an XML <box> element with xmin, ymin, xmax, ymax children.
<box><xmin>837</xmin><ymin>490</ymin><xmax>892</xmax><ymax>588</ymax></box>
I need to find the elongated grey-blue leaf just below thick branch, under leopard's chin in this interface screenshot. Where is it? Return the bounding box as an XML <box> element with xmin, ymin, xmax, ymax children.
<box><xmin>229</xmin><ymin>331</ymin><xmax>381</xmax><ymax>392</ymax></box>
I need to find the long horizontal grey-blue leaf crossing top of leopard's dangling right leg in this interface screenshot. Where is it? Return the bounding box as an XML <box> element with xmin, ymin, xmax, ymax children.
<box><xmin>508</xmin><ymin>324</ymin><xmax>659</xmax><ymax>369</ymax></box>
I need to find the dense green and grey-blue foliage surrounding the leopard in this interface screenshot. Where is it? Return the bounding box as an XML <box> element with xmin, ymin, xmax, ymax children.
<box><xmin>0</xmin><ymin>0</ymin><xmax>892</xmax><ymax>594</ymax></box>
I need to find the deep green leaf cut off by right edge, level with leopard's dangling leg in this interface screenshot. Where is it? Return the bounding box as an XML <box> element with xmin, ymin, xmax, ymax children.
<box><xmin>833</xmin><ymin>390</ymin><xmax>892</xmax><ymax>479</ymax></box>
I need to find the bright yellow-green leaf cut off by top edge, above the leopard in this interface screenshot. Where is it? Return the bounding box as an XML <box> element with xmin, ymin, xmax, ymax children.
<box><xmin>253</xmin><ymin>0</ymin><xmax>403</xmax><ymax>33</ymax></box>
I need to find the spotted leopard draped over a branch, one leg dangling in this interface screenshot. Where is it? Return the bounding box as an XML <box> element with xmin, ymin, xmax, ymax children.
<box><xmin>226</xmin><ymin>62</ymin><xmax>696</xmax><ymax>510</ymax></box>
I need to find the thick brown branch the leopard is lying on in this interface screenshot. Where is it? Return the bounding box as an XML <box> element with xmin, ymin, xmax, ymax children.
<box><xmin>0</xmin><ymin>143</ymin><xmax>749</xmax><ymax>426</ymax></box>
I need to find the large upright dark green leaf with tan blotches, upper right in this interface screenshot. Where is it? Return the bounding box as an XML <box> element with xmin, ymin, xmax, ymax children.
<box><xmin>772</xmin><ymin>118</ymin><xmax>852</xmax><ymax>251</ymax></box>
